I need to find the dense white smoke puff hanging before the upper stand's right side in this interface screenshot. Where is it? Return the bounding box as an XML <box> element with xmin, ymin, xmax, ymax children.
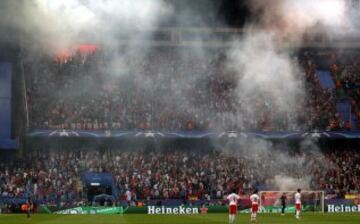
<box><xmin>229</xmin><ymin>32</ymin><xmax>303</xmax><ymax>121</ymax></box>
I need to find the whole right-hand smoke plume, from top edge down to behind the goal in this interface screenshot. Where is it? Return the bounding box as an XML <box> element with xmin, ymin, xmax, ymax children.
<box><xmin>221</xmin><ymin>0</ymin><xmax>351</xmax><ymax>190</ymax></box>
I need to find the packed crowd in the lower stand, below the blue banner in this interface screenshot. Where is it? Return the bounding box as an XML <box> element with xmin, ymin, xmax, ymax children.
<box><xmin>0</xmin><ymin>147</ymin><xmax>360</xmax><ymax>206</ymax></box>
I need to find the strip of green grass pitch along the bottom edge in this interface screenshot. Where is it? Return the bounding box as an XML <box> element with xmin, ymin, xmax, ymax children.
<box><xmin>0</xmin><ymin>213</ymin><xmax>360</xmax><ymax>224</ymax></box>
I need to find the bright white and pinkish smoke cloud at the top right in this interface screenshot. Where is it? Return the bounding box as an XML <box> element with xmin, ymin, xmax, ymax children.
<box><xmin>249</xmin><ymin>0</ymin><xmax>352</xmax><ymax>41</ymax></box>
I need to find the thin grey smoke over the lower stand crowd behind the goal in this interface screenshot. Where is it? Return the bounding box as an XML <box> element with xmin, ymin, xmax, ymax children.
<box><xmin>219</xmin><ymin>138</ymin><xmax>338</xmax><ymax>191</ymax></box>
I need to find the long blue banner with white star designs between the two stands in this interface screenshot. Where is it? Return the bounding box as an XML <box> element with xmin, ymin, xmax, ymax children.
<box><xmin>27</xmin><ymin>129</ymin><xmax>360</xmax><ymax>139</ymax></box>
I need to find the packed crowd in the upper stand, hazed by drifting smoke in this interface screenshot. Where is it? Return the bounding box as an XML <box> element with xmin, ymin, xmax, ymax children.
<box><xmin>24</xmin><ymin>49</ymin><xmax>344</xmax><ymax>131</ymax></box>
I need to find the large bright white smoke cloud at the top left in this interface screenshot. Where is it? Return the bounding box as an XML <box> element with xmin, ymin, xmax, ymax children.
<box><xmin>1</xmin><ymin>0</ymin><xmax>172</xmax><ymax>51</ymax></box>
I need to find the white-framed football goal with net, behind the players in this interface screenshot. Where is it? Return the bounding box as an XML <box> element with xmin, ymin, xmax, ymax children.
<box><xmin>259</xmin><ymin>191</ymin><xmax>325</xmax><ymax>213</ymax></box>
